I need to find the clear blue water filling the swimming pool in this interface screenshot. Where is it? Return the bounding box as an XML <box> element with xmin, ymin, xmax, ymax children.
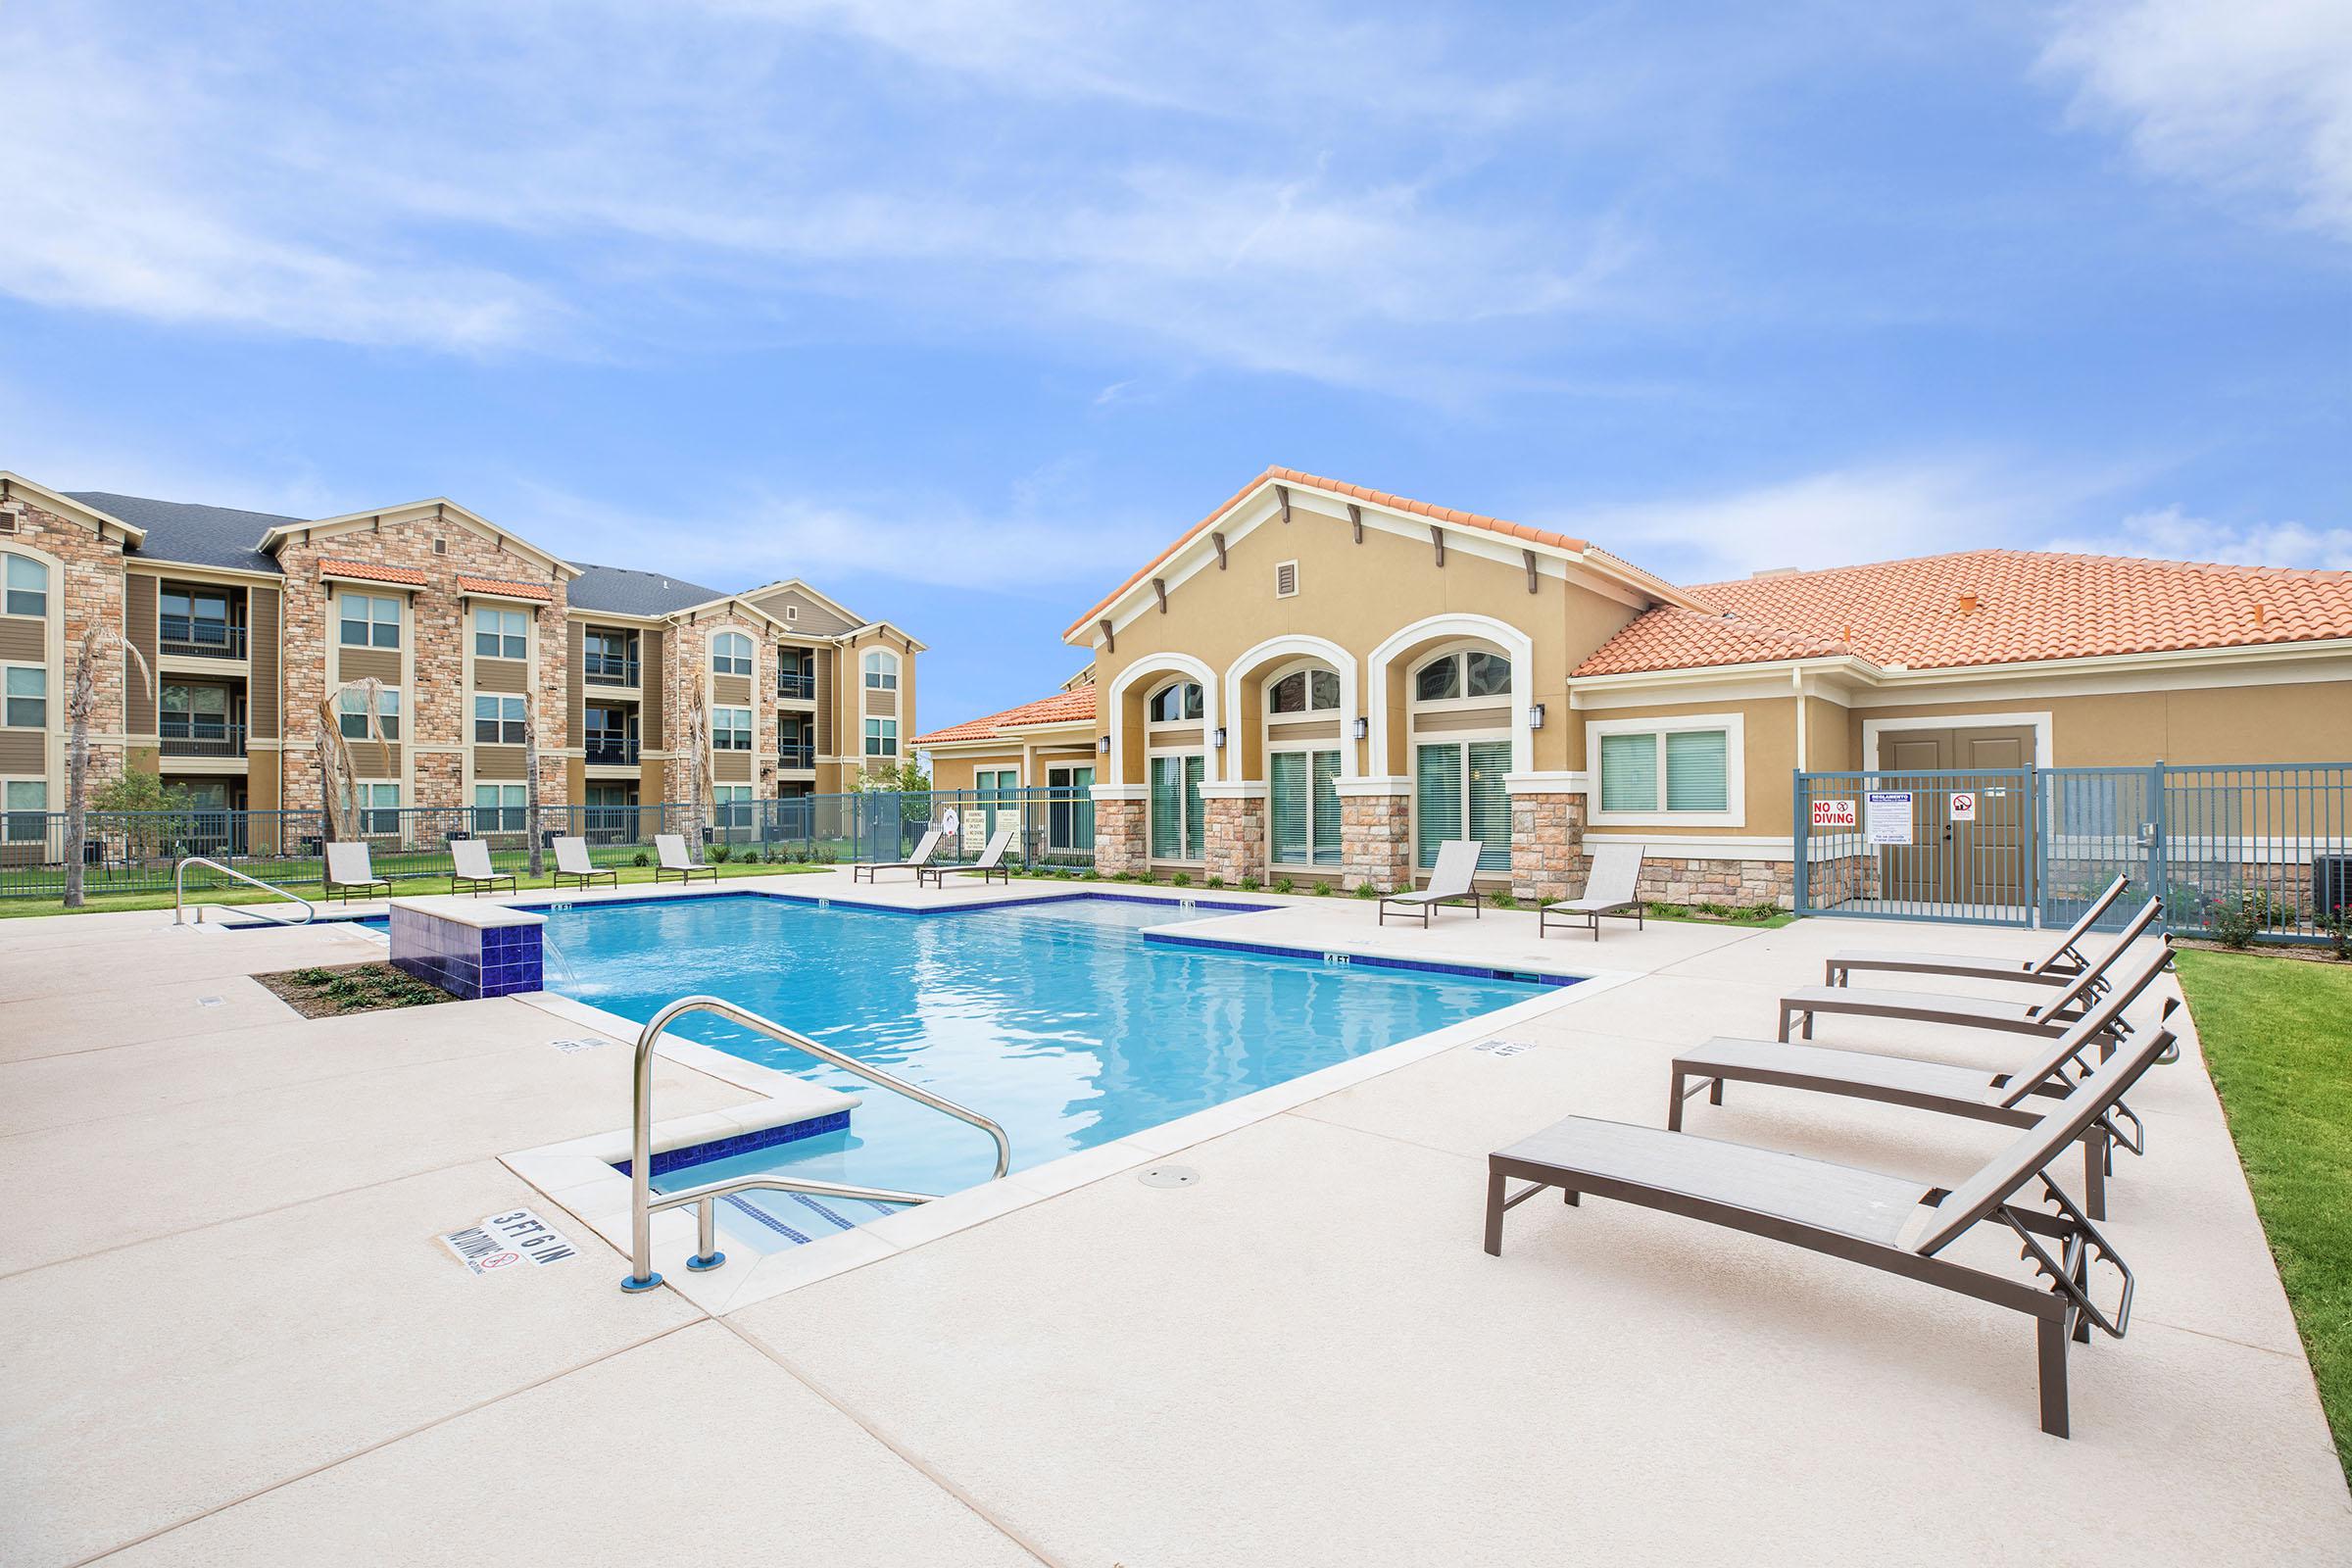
<box><xmin>548</xmin><ymin>896</ymin><xmax>1557</xmax><ymax>1249</ymax></box>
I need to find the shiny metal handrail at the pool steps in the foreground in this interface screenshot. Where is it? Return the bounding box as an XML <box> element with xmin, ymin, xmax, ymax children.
<box><xmin>621</xmin><ymin>997</ymin><xmax>1013</xmax><ymax>1293</ymax></box>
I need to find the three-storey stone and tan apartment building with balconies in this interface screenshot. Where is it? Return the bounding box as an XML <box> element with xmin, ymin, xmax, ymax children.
<box><xmin>0</xmin><ymin>470</ymin><xmax>924</xmax><ymax>837</ymax></box>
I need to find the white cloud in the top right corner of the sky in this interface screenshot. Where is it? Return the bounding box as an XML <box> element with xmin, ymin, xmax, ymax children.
<box><xmin>2041</xmin><ymin>0</ymin><xmax>2352</xmax><ymax>240</ymax></box>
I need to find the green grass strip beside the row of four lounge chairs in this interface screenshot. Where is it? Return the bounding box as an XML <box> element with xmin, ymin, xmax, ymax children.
<box><xmin>2178</xmin><ymin>953</ymin><xmax>2352</xmax><ymax>1474</ymax></box>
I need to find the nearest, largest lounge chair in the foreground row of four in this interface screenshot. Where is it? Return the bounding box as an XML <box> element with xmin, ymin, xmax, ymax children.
<box><xmin>1487</xmin><ymin>1027</ymin><xmax>2174</xmax><ymax>1437</ymax></box>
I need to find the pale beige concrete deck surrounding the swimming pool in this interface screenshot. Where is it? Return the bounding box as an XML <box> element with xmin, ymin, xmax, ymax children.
<box><xmin>0</xmin><ymin>872</ymin><xmax>2352</xmax><ymax>1568</ymax></box>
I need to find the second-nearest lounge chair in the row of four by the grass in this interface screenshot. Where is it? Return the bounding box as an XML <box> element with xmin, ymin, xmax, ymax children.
<box><xmin>1665</xmin><ymin>945</ymin><xmax>2178</xmax><ymax>1220</ymax></box>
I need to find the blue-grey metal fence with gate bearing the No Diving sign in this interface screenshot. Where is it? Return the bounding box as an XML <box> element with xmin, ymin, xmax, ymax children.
<box><xmin>1794</xmin><ymin>764</ymin><xmax>2352</xmax><ymax>941</ymax></box>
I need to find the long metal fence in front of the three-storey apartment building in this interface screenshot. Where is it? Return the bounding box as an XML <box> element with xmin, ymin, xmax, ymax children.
<box><xmin>0</xmin><ymin>788</ymin><xmax>1094</xmax><ymax>898</ymax></box>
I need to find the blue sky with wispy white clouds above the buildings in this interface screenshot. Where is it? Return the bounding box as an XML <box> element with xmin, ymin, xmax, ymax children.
<box><xmin>0</xmin><ymin>0</ymin><xmax>2352</xmax><ymax>726</ymax></box>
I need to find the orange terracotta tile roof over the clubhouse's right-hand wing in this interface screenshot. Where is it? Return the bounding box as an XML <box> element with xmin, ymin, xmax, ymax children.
<box><xmin>1574</xmin><ymin>550</ymin><xmax>2352</xmax><ymax>674</ymax></box>
